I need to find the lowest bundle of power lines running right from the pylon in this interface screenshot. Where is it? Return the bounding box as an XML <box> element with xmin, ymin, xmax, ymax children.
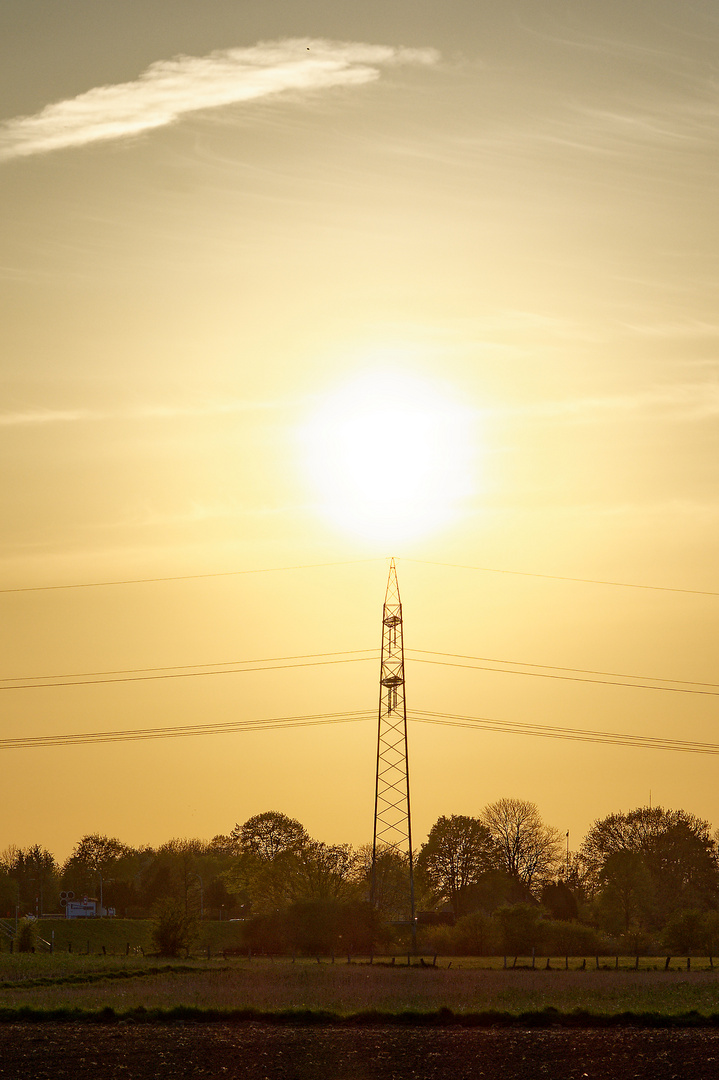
<box><xmin>409</xmin><ymin>710</ymin><xmax>719</xmax><ymax>754</ymax></box>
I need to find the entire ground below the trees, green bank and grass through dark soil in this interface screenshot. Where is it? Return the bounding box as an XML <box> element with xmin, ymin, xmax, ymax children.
<box><xmin>0</xmin><ymin>922</ymin><xmax>719</xmax><ymax>1080</ymax></box>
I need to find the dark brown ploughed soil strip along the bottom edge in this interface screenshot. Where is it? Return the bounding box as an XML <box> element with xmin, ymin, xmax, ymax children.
<box><xmin>0</xmin><ymin>1024</ymin><xmax>719</xmax><ymax>1080</ymax></box>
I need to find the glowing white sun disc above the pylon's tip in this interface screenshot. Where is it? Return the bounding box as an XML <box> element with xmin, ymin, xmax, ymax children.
<box><xmin>301</xmin><ymin>369</ymin><xmax>476</xmax><ymax>545</ymax></box>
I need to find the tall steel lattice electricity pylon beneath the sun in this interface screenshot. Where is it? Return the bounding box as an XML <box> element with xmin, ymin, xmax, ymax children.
<box><xmin>370</xmin><ymin>559</ymin><xmax>417</xmax><ymax>949</ymax></box>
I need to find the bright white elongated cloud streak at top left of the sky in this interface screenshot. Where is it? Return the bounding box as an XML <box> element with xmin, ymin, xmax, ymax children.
<box><xmin>0</xmin><ymin>38</ymin><xmax>438</xmax><ymax>161</ymax></box>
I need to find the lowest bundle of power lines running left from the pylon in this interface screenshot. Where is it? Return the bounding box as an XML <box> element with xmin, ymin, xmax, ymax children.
<box><xmin>0</xmin><ymin>710</ymin><xmax>375</xmax><ymax>750</ymax></box>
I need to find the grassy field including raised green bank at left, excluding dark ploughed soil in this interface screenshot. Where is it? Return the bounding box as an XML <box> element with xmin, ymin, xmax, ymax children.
<box><xmin>0</xmin><ymin>920</ymin><xmax>719</xmax><ymax>1021</ymax></box>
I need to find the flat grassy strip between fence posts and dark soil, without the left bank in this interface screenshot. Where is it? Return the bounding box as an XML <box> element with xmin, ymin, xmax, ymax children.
<box><xmin>0</xmin><ymin>953</ymin><xmax>719</xmax><ymax>1018</ymax></box>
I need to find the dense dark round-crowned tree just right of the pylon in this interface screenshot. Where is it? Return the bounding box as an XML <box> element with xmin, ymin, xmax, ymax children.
<box><xmin>417</xmin><ymin>814</ymin><xmax>499</xmax><ymax>917</ymax></box>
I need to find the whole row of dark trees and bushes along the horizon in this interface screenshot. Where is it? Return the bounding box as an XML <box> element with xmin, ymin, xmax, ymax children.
<box><xmin>0</xmin><ymin>798</ymin><xmax>719</xmax><ymax>955</ymax></box>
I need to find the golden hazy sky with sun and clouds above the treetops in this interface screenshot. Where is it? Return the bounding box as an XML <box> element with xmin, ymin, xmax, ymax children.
<box><xmin>0</xmin><ymin>0</ymin><xmax>719</xmax><ymax>859</ymax></box>
